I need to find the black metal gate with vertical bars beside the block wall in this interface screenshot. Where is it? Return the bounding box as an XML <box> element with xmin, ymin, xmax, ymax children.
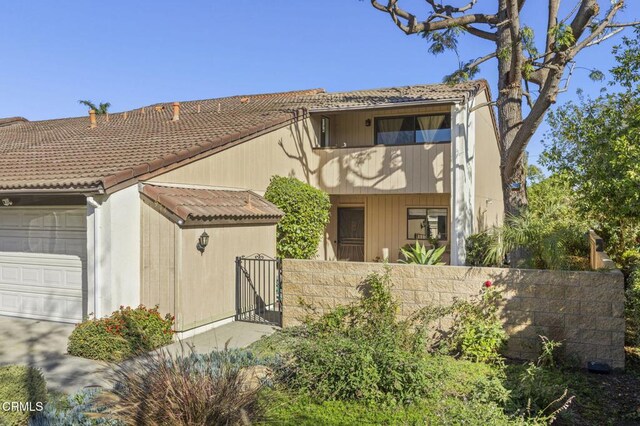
<box><xmin>236</xmin><ymin>254</ymin><xmax>282</xmax><ymax>326</ymax></box>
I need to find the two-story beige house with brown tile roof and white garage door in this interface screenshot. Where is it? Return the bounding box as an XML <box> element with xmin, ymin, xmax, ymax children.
<box><xmin>0</xmin><ymin>81</ymin><xmax>503</xmax><ymax>331</ymax></box>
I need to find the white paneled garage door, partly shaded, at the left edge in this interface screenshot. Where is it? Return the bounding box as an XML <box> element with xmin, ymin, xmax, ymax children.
<box><xmin>0</xmin><ymin>206</ymin><xmax>87</xmax><ymax>322</ymax></box>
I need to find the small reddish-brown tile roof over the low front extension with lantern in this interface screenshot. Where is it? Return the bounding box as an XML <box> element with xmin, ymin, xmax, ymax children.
<box><xmin>140</xmin><ymin>184</ymin><xmax>284</xmax><ymax>226</ymax></box>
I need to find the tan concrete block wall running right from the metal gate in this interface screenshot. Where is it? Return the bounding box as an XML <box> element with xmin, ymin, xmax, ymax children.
<box><xmin>282</xmin><ymin>259</ymin><xmax>625</xmax><ymax>368</ymax></box>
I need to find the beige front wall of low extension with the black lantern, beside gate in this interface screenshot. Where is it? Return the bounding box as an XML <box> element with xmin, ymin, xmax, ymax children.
<box><xmin>179</xmin><ymin>225</ymin><xmax>276</xmax><ymax>331</ymax></box>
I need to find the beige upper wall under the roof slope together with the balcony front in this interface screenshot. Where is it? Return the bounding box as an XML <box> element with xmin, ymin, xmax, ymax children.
<box><xmin>151</xmin><ymin>111</ymin><xmax>451</xmax><ymax>194</ymax></box>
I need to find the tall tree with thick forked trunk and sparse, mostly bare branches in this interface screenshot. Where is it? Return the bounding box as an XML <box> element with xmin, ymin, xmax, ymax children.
<box><xmin>370</xmin><ymin>0</ymin><xmax>638</xmax><ymax>214</ymax></box>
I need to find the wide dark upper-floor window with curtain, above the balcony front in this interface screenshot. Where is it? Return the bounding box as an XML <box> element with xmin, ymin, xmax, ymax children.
<box><xmin>375</xmin><ymin>114</ymin><xmax>451</xmax><ymax>145</ymax></box>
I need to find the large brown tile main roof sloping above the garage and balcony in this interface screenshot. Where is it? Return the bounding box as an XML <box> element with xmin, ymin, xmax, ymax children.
<box><xmin>0</xmin><ymin>80</ymin><xmax>488</xmax><ymax>192</ymax></box>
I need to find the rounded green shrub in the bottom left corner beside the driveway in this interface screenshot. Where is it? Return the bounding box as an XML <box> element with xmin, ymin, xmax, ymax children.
<box><xmin>0</xmin><ymin>365</ymin><xmax>47</xmax><ymax>426</ymax></box>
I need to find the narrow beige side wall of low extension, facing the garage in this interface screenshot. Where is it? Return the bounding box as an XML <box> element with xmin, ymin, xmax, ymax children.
<box><xmin>140</xmin><ymin>202</ymin><xmax>177</xmax><ymax>322</ymax></box>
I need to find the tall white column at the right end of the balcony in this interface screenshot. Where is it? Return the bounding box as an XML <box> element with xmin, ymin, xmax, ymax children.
<box><xmin>450</xmin><ymin>101</ymin><xmax>476</xmax><ymax>265</ymax></box>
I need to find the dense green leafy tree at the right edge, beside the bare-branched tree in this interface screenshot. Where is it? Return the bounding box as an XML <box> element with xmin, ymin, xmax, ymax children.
<box><xmin>541</xmin><ymin>31</ymin><xmax>640</xmax><ymax>255</ymax></box>
